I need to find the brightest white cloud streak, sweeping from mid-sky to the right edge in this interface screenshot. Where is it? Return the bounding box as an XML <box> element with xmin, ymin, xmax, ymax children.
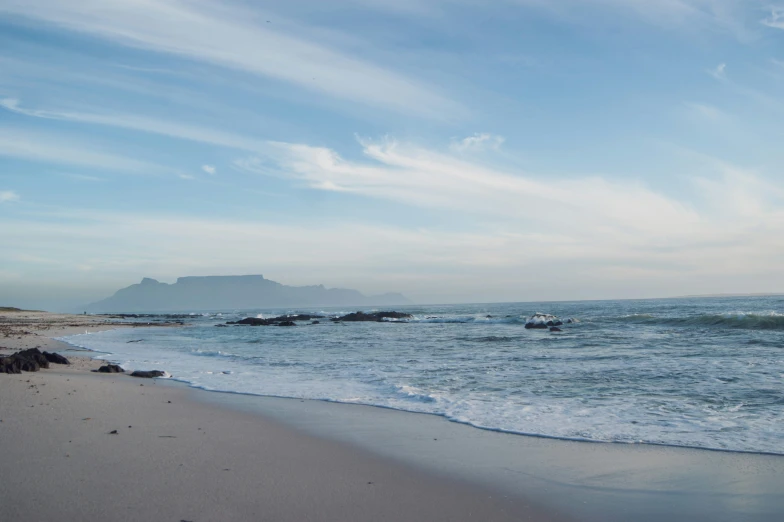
<box><xmin>237</xmin><ymin>134</ymin><xmax>784</xmax><ymax>253</ymax></box>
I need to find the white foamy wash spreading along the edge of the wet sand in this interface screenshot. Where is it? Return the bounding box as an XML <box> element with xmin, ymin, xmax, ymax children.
<box><xmin>62</xmin><ymin>330</ymin><xmax>780</xmax><ymax>454</ymax></box>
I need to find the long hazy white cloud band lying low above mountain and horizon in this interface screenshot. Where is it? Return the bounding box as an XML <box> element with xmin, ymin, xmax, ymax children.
<box><xmin>0</xmin><ymin>173</ymin><xmax>784</xmax><ymax>302</ymax></box>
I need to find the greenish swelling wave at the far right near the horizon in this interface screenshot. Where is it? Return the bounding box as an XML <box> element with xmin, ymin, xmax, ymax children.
<box><xmin>617</xmin><ymin>311</ymin><xmax>784</xmax><ymax>330</ymax></box>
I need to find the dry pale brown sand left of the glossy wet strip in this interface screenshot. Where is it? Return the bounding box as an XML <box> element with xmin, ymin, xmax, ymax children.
<box><xmin>0</xmin><ymin>314</ymin><xmax>562</xmax><ymax>522</ymax></box>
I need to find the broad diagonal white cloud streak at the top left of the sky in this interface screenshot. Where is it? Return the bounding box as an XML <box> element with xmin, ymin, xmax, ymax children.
<box><xmin>0</xmin><ymin>0</ymin><xmax>462</xmax><ymax>118</ymax></box>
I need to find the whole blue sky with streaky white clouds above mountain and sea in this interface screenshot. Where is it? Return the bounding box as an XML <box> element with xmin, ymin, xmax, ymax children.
<box><xmin>0</xmin><ymin>0</ymin><xmax>784</xmax><ymax>309</ymax></box>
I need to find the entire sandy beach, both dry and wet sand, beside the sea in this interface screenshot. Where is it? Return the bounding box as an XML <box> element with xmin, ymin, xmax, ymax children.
<box><xmin>0</xmin><ymin>313</ymin><xmax>784</xmax><ymax>522</ymax></box>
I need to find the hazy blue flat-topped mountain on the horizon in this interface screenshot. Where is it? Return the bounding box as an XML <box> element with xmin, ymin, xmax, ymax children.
<box><xmin>86</xmin><ymin>275</ymin><xmax>410</xmax><ymax>313</ymax></box>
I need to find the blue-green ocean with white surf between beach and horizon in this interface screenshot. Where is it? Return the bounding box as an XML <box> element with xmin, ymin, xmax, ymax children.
<box><xmin>63</xmin><ymin>296</ymin><xmax>784</xmax><ymax>454</ymax></box>
